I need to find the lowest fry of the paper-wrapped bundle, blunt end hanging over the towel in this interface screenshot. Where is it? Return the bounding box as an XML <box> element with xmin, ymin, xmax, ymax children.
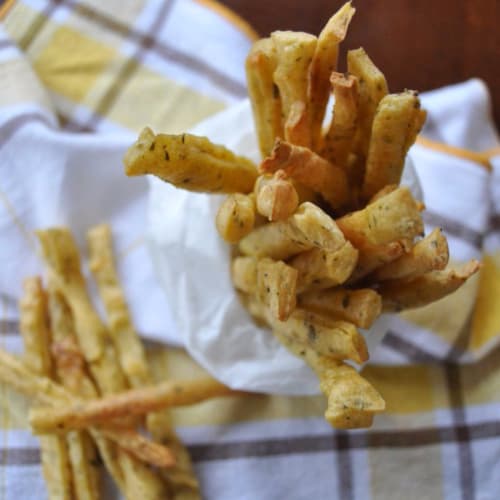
<box><xmin>273</xmin><ymin>318</ymin><xmax>385</xmax><ymax>429</ymax></box>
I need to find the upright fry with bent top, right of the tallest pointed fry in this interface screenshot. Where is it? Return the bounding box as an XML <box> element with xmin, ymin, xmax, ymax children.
<box><xmin>347</xmin><ymin>48</ymin><xmax>388</xmax><ymax>159</ymax></box>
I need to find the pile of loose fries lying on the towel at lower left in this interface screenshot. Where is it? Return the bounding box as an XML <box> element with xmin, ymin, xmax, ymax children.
<box><xmin>0</xmin><ymin>225</ymin><xmax>242</xmax><ymax>500</ymax></box>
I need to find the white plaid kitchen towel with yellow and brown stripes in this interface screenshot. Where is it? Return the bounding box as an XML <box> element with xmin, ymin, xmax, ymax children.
<box><xmin>0</xmin><ymin>0</ymin><xmax>500</xmax><ymax>500</ymax></box>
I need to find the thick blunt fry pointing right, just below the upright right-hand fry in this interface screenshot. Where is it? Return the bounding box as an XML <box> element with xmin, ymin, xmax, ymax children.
<box><xmin>336</xmin><ymin>187</ymin><xmax>424</xmax><ymax>250</ymax></box>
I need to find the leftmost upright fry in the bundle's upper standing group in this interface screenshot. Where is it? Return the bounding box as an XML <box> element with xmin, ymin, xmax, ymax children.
<box><xmin>245</xmin><ymin>38</ymin><xmax>283</xmax><ymax>158</ymax></box>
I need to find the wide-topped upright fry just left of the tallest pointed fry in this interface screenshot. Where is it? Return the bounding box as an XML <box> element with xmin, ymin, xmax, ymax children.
<box><xmin>271</xmin><ymin>31</ymin><xmax>317</xmax><ymax>146</ymax></box>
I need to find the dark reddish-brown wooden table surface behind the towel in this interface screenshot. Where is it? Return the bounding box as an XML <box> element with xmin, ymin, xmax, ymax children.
<box><xmin>222</xmin><ymin>0</ymin><xmax>500</xmax><ymax>128</ymax></box>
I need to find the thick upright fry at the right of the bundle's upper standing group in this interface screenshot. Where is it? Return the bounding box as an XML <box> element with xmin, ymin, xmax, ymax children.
<box><xmin>362</xmin><ymin>91</ymin><xmax>421</xmax><ymax>199</ymax></box>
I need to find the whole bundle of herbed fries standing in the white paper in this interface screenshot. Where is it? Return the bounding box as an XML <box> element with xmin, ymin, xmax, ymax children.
<box><xmin>125</xmin><ymin>3</ymin><xmax>479</xmax><ymax>428</ymax></box>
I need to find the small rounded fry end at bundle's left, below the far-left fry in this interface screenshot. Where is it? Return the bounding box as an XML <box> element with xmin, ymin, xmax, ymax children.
<box><xmin>215</xmin><ymin>193</ymin><xmax>255</xmax><ymax>243</ymax></box>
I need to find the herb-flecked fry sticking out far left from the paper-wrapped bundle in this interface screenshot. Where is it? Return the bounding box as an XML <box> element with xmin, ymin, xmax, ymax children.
<box><xmin>123</xmin><ymin>128</ymin><xmax>257</xmax><ymax>193</ymax></box>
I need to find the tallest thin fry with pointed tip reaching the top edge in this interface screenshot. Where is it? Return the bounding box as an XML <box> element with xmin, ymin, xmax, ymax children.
<box><xmin>308</xmin><ymin>2</ymin><xmax>356</xmax><ymax>151</ymax></box>
